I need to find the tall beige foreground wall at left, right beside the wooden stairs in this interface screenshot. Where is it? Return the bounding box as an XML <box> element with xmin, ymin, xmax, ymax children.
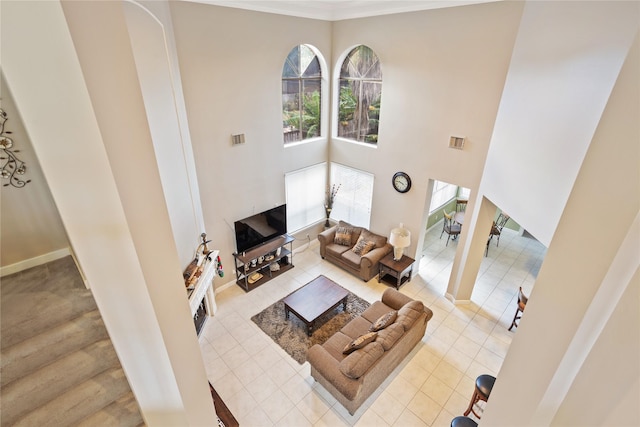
<box><xmin>2</xmin><ymin>2</ymin><xmax>216</xmax><ymax>426</ymax></box>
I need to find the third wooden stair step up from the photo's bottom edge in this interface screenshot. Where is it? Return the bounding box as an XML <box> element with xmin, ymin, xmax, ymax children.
<box><xmin>1</xmin><ymin>339</ymin><xmax>120</xmax><ymax>425</ymax></box>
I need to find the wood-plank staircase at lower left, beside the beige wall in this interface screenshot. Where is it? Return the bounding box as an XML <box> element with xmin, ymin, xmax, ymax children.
<box><xmin>0</xmin><ymin>256</ymin><xmax>144</xmax><ymax>427</ymax></box>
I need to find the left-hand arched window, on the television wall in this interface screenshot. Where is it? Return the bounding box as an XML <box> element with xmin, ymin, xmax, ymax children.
<box><xmin>282</xmin><ymin>44</ymin><xmax>322</xmax><ymax>144</ymax></box>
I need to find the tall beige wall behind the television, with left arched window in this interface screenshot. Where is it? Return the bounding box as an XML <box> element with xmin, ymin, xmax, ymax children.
<box><xmin>170</xmin><ymin>2</ymin><xmax>332</xmax><ymax>287</ymax></box>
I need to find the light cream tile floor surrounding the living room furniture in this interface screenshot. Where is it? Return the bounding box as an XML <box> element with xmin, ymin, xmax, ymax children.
<box><xmin>200</xmin><ymin>226</ymin><xmax>546</xmax><ymax>427</ymax></box>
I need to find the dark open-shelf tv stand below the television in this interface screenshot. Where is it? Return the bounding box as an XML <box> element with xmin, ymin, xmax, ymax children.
<box><xmin>233</xmin><ymin>234</ymin><xmax>295</xmax><ymax>292</ymax></box>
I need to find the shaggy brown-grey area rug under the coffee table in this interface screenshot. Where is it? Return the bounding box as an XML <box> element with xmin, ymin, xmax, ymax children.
<box><xmin>251</xmin><ymin>284</ymin><xmax>370</xmax><ymax>364</ymax></box>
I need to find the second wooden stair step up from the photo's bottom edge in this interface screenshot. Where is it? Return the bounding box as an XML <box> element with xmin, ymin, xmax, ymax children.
<box><xmin>12</xmin><ymin>368</ymin><xmax>139</xmax><ymax>427</ymax></box>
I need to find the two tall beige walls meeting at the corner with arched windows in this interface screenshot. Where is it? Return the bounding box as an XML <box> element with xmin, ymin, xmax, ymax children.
<box><xmin>171</xmin><ymin>2</ymin><xmax>522</xmax><ymax>278</ymax></box>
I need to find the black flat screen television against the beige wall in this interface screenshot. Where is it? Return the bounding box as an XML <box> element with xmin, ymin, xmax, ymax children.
<box><xmin>234</xmin><ymin>204</ymin><xmax>287</xmax><ymax>253</ymax></box>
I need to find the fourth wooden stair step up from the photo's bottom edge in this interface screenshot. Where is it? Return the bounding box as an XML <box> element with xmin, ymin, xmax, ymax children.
<box><xmin>0</xmin><ymin>310</ymin><xmax>108</xmax><ymax>387</ymax></box>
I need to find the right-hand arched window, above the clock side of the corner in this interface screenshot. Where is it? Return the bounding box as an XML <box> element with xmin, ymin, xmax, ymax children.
<box><xmin>338</xmin><ymin>45</ymin><xmax>382</xmax><ymax>144</ymax></box>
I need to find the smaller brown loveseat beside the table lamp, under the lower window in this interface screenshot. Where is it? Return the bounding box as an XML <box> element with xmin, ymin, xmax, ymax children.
<box><xmin>318</xmin><ymin>221</ymin><xmax>393</xmax><ymax>282</ymax></box>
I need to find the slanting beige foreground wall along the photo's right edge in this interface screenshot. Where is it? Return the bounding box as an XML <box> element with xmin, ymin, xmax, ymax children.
<box><xmin>482</xmin><ymin>28</ymin><xmax>640</xmax><ymax>426</ymax></box>
